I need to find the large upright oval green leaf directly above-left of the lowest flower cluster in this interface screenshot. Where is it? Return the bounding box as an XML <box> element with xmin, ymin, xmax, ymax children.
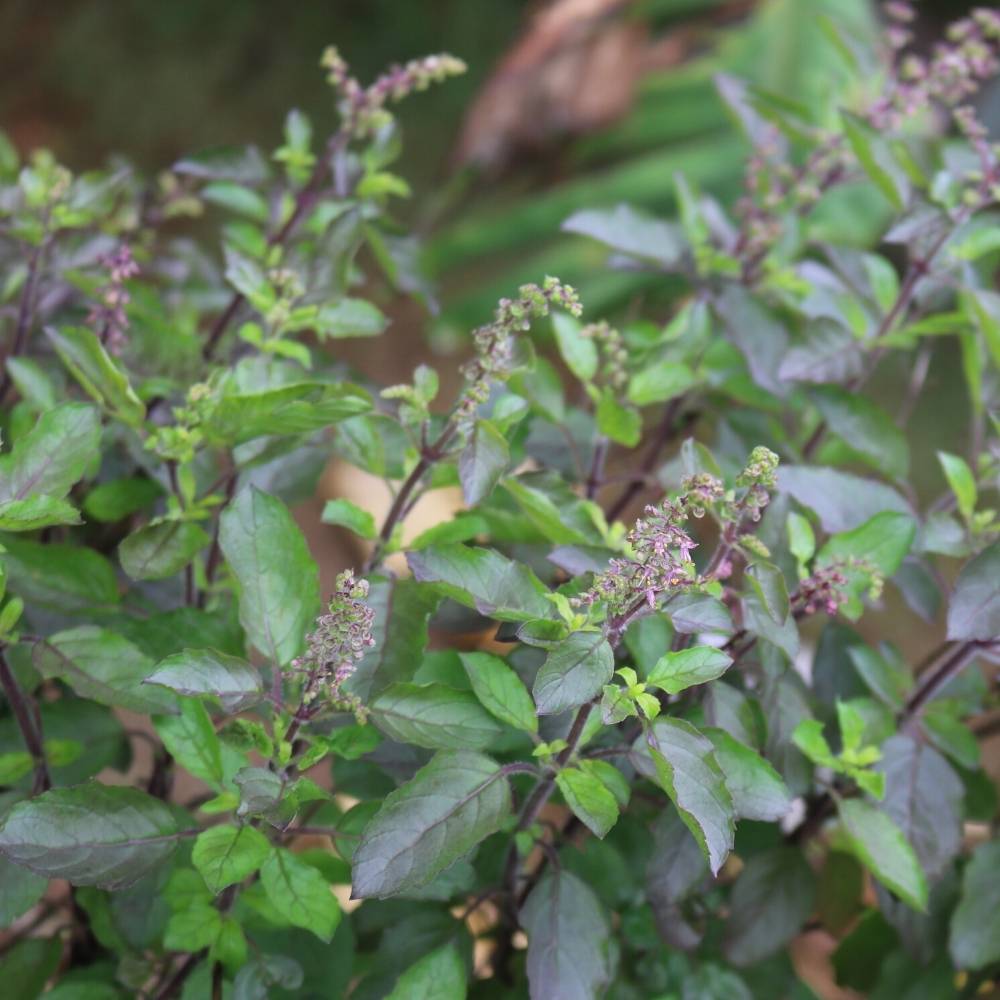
<box><xmin>219</xmin><ymin>486</ymin><xmax>319</xmax><ymax>666</ymax></box>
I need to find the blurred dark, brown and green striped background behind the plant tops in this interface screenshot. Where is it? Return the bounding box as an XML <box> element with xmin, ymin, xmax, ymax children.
<box><xmin>0</xmin><ymin>0</ymin><xmax>984</xmax><ymax>330</ymax></box>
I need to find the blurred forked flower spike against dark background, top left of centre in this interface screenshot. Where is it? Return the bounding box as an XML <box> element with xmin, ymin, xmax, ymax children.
<box><xmin>320</xmin><ymin>45</ymin><xmax>466</xmax><ymax>139</ymax></box>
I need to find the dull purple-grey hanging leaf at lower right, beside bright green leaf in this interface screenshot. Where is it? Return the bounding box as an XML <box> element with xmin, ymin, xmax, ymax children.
<box><xmin>877</xmin><ymin>733</ymin><xmax>965</xmax><ymax>880</ymax></box>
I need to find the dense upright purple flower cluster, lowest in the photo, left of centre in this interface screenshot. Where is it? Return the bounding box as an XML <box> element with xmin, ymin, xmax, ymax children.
<box><xmin>292</xmin><ymin>570</ymin><xmax>375</xmax><ymax>713</ymax></box>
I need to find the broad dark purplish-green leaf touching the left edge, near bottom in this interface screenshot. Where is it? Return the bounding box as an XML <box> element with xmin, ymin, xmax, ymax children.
<box><xmin>0</xmin><ymin>782</ymin><xmax>177</xmax><ymax>889</ymax></box>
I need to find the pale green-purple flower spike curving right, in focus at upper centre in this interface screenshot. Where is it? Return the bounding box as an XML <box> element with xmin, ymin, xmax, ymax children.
<box><xmin>455</xmin><ymin>277</ymin><xmax>583</xmax><ymax>426</ymax></box>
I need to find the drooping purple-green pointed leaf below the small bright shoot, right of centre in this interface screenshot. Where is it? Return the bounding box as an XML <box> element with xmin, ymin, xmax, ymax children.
<box><xmin>635</xmin><ymin>716</ymin><xmax>736</xmax><ymax>875</ymax></box>
